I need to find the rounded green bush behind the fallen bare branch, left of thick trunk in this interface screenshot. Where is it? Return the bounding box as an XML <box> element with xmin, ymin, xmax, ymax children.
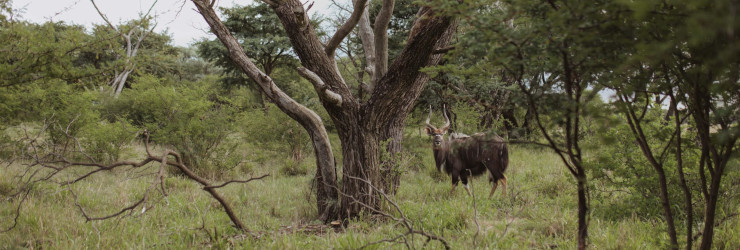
<box><xmin>102</xmin><ymin>76</ymin><xmax>249</xmax><ymax>178</ymax></box>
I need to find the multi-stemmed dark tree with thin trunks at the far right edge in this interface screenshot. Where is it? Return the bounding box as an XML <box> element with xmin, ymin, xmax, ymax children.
<box><xmin>615</xmin><ymin>0</ymin><xmax>740</xmax><ymax>249</ymax></box>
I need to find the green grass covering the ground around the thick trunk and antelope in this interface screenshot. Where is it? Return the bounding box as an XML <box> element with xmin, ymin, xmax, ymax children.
<box><xmin>0</xmin><ymin>140</ymin><xmax>740</xmax><ymax>249</ymax></box>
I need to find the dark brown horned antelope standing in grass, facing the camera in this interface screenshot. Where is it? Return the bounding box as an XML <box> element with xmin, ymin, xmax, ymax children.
<box><xmin>425</xmin><ymin>106</ymin><xmax>509</xmax><ymax>198</ymax></box>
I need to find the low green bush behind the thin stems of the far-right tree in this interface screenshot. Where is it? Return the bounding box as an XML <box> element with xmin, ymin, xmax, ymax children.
<box><xmin>584</xmin><ymin>108</ymin><xmax>701</xmax><ymax>220</ymax></box>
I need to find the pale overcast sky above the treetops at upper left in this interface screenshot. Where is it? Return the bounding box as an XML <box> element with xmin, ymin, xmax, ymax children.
<box><xmin>12</xmin><ymin>0</ymin><xmax>342</xmax><ymax>46</ymax></box>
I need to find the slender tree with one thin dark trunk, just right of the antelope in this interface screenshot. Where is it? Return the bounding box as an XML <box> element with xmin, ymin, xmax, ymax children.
<box><xmin>440</xmin><ymin>0</ymin><xmax>632</xmax><ymax>249</ymax></box>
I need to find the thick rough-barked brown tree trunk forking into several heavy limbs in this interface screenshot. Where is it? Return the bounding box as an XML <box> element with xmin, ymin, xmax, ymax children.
<box><xmin>192</xmin><ymin>0</ymin><xmax>456</xmax><ymax>220</ymax></box>
